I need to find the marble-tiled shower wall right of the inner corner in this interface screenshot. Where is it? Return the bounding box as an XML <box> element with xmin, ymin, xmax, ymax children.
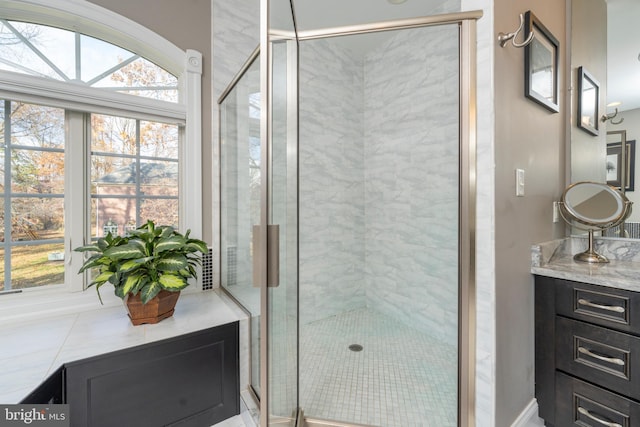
<box><xmin>364</xmin><ymin>25</ymin><xmax>459</xmax><ymax>345</ymax></box>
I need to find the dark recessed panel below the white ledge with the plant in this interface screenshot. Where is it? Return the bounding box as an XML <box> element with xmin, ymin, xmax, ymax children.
<box><xmin>66</xmin><ymin>322</ymin><xmax>239</xmax><ymax>427</ymax></box>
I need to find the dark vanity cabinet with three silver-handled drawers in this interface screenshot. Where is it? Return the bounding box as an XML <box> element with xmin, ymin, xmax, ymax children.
<box><xmin>535</xmin><ymin>276</ymin><xmax>640</xmax><ymax>427</ymax></box>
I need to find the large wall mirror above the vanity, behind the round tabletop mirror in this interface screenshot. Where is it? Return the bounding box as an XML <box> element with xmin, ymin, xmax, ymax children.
<box><xmin>565</xmin><ymin>0</ymin><xmax>640</xmax><ymax>239</ymax></box>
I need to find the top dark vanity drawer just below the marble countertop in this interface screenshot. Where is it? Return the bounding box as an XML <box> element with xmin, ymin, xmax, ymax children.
<box><xmin>556</xmin><ymin>279</ymin><xmax>640</xmax><ymax>334</ymax></box>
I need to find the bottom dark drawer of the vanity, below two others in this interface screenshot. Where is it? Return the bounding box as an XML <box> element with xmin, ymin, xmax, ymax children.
<box><xmin>555</xmin><ymin>372</ymin><xmax>640</xmax><ymax>427</ymax></box>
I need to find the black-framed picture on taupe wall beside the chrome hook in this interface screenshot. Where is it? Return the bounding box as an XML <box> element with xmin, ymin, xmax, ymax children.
<box><xmin>524</xmin><ymin>10</ymin><xmax>560</xmax><ymax>113</ymax></box>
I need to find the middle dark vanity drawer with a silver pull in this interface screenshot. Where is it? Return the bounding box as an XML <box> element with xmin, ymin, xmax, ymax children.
<box><xmin>555</xmin><ymin>316</ymin><xmax>640</xmax><ymax>400</ymax></box>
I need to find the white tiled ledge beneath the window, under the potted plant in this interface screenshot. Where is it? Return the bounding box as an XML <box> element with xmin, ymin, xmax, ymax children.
<box><xmin>0</xmin><ymin>290</ymin><xmax>242</xmax><ymax>404</ymax></box>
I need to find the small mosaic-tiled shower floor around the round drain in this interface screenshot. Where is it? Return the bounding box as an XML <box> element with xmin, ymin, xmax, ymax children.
<box><xmin>300</xmin><ymin>309</ymin><xmax>457</xmax><ymax>427</ymax></box>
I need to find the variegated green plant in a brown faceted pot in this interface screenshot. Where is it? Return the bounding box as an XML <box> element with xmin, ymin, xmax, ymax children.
<box><xmin>75</xmin><ymin>221</ymin><xmax>207</xmax><ymax>325</ymax></box>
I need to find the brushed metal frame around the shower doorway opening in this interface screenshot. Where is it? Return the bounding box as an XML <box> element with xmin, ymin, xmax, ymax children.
<box><xmin>259</xmin><ymin>0</ymin><xmax>482</xmax><ymax>427</ymax></box>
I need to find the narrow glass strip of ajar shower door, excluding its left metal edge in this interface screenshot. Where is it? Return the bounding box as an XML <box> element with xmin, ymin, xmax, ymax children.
<box><xmin>265</xmin><ymin>40</ymin><xmax>298</xmax><ymax>426</ymax></box>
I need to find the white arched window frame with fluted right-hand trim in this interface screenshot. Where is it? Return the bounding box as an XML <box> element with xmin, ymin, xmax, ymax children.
<box><xmin>0</xmin><ymin>0</ymin><xmax>202</xmax><ymax>291</ymax></box>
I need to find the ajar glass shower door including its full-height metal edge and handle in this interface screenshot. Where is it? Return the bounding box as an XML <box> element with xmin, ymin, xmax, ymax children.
<box><xmin>260</xmin><ymin>0</ymin><xmax>302</xmax><ymax>427</ymax></box>
